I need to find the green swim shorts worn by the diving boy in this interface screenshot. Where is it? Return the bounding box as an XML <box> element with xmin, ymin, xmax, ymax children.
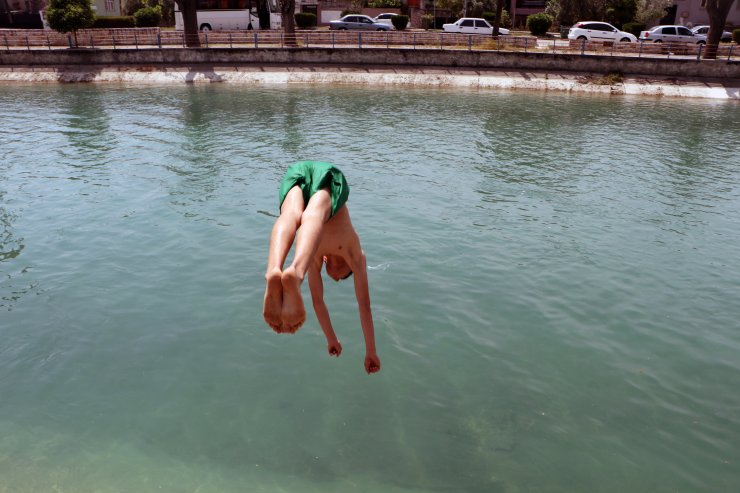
<box><xmin>280</xmin><ymin>161</ymin><xmax>349</xmax><ymax>216</ymax></box>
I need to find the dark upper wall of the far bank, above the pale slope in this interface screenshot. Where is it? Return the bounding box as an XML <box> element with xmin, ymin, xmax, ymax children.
<box><xmin>0</xmin><ymin>48</ymin><xmax>740</xmax><ymax>80</ymax></box>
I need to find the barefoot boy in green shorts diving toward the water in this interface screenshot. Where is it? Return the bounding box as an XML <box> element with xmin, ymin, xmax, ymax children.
<box><xmin>263</xmin><ymin>161</ymin><xmax>380</xmax><ymax>373</ymax></box>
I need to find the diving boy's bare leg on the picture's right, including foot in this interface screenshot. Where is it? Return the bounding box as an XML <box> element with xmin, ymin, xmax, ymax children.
<box><xmin>281</xmin><ymin>189</ymin><xmax>331</xmax><ymax>332</ymax></box>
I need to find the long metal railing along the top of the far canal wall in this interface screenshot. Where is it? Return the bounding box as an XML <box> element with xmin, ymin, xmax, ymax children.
<box><xmin>0</xmin><ymin>28</ymin><xmax>740</xmax><ymax>60</ymax></box>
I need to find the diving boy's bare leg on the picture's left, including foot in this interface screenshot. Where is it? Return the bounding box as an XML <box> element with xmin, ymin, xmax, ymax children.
<box><xmin>262</xmin><ymin>186</ymin><xmax>304</xmax><ymax>332</ymax></box>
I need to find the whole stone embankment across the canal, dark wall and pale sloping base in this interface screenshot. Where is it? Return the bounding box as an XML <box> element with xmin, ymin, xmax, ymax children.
<box><xmin>0</xmin><ymin>43</ymin><xmax>740</xmax><ymax>100</ymax></box>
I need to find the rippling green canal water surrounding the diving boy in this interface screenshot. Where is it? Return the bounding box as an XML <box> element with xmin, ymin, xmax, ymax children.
<box><xmin>0</xmin><ymin>85</ymin><xmax>740</xmax><ymax>493</ymax></box>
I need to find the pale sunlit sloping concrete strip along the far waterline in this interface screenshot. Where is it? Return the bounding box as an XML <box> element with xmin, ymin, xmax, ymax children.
<box><xmin>0</xmin><ymin>64</ymin><xmax>740</xmax><ymax>101</ymax></box>
